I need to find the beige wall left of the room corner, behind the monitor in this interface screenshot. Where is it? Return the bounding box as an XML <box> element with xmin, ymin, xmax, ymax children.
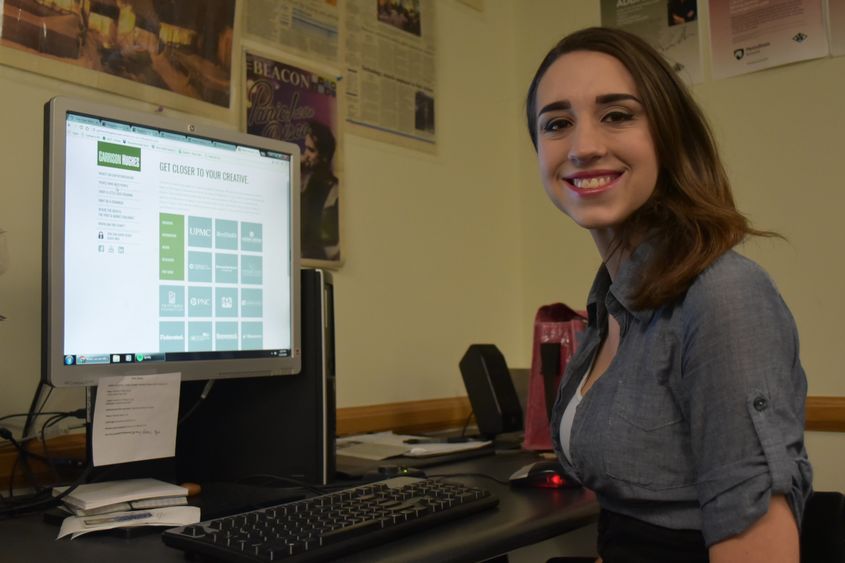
<box><xmin>0</xmin><ymin>1</ymin><xmax>527</xmax><ymax>414</ymax></box>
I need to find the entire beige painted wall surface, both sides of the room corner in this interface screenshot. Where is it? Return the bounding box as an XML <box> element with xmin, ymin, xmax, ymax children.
<box><xmin>0</xmin><ymin>0</ymin><xmax>845</xmax><ymax>490</ymax></box>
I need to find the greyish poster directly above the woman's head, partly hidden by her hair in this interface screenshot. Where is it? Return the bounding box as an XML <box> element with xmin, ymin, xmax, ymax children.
<box><xmin>601</xmin><ymin>0</ymin><xmax>704</xmax><ymax>84</ymax></box>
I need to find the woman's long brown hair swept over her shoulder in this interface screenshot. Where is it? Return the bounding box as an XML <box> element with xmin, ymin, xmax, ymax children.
<box><xmin>526</xmin><ymin>27</ymin><xmax>779</xmax><ymax>309</ymax></box>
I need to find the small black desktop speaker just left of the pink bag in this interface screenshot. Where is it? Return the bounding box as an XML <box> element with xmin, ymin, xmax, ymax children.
<box><xmin>460</xmin><ymin>344</ymin><xmax>522</xmax><ymax>438</ymax></box>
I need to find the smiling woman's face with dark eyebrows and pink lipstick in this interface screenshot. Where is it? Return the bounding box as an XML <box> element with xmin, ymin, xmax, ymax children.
<box><xmin>536</xmin><ymin>51</ymin><xmax>659</xmax><ymax>235</ymax></box>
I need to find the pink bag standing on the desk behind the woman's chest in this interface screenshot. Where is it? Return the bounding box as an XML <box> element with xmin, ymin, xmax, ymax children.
<box><xmin>522</xmin><ymin>303</ymin><xmax>587</xmax><ymax>450</ymax></box>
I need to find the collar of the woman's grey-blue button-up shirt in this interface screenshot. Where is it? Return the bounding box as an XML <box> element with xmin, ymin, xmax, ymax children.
<box><xmin>587</xmin><ymin>242</ymin><xmax>654</xmax><ymax>326</ymax></box>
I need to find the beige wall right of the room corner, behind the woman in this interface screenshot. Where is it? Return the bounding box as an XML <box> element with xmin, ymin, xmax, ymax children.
<box><xmin>514</xmin><ymin>0</ymin><xmax>845</xmax><ymax>490</ymax></box>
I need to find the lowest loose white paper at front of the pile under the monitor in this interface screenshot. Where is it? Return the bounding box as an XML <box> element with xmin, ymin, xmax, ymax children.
<box><xmin>56</xmin><ymin>506</ymin><xmax>200</xmax><ymax>539</ymax></box>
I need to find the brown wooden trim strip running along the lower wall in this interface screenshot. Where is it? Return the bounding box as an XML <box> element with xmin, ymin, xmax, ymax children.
<box><xmin>0</xmin><ymin>396</ymin><xmax>845</xmax><ymax>488</ymax></box>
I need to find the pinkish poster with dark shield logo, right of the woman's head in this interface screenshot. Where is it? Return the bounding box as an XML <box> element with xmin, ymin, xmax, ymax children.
<box><xmin>709</xmin><ymin>0</ymin><xmax>828</xmax><ymax>79</ymax></box>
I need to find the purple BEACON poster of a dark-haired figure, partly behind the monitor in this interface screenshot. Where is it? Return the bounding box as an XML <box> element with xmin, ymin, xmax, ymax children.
<box><xmin>245</xmin><ymin>51</ymin><xmax>342</xmax><ymax>267</ymax></box>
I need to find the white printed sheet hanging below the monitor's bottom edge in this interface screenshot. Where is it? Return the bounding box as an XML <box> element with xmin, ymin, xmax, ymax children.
<box><xmin>92</xmin><ymin>373</ymin><xmax>182</xmax><ymax>466</ymax></box>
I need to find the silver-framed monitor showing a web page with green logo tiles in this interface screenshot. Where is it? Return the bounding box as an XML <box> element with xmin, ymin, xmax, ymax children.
<box><xmin>42</xmin><ymin>98</ymin><xmax>301</xmax><ymax>386</ymax></box>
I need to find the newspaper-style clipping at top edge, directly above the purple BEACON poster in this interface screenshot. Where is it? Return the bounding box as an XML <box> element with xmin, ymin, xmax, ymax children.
<box><xmin>244</xmin><ymin>0</ymin><xmax>340</xmax><ymax>64</ymax></box>
